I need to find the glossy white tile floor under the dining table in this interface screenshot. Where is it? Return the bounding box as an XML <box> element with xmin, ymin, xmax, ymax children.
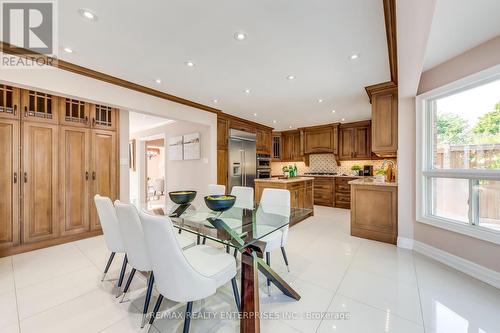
<box><xmin>0</xmin><ymin>207</ymin><xmax>500</xmax><ymax>333</ymax></box>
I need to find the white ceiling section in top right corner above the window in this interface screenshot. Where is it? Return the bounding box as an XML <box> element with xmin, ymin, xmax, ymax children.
<box><xmin>424</xmin><ymin>0</ymin><xmax>500</xmax><ymax>70</ymax></box>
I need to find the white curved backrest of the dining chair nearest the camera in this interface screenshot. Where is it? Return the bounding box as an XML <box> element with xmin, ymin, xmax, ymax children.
<box><xmin>139</xmin><ymin>212</ymin><xmax>216</xmax><ymax>302</ymax></box>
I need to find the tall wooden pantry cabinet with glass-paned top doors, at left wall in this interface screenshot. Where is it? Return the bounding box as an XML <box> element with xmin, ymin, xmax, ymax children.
<box><xmin>0</xmin><ymin>85</ymin><xmax>119</xmax><ymax>257</ymax></box>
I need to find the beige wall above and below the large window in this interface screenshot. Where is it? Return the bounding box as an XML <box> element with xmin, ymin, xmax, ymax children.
<box><xmin>414</xmin><ymin>36</ymin><xmax>500</xmax><ymax>272</ymax></box>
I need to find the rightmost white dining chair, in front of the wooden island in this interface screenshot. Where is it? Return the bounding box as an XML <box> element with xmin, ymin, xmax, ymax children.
<box><xmin>256</xmin><ymin>188</ymin><xmax>290</xmax><ymax>294</ymax></box>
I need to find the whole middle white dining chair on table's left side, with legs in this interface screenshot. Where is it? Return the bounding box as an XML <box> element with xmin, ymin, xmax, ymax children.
<box><xmin>115</xmin><ymin>200</ymin><xmax>194</xmax><ymax>328</ymax></box>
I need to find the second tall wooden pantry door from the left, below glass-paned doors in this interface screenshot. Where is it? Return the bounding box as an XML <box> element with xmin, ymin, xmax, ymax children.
<box><xmin>22</xmin><ymin>122</ymin><xmax>59</xmax><ymax>243</ymax></box>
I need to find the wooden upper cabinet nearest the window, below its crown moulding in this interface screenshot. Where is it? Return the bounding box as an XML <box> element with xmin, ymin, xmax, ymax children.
<box><xmin>371</xmin><ymin>89</ymin><xmax>398</xmax><ymax>157</ymax></box>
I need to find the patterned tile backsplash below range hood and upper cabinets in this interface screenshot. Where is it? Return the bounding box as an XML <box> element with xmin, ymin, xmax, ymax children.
<box><xmin>271</xmin><ymin>154</ymin><xmax>396</xmax><ymax>176</ymax></box>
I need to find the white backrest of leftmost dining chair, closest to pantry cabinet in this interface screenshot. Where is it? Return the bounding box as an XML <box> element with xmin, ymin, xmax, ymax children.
<box><xmin>94</xmin><ymin>194</ymin><xmax>125</xmax><ymax>253</ymax></box>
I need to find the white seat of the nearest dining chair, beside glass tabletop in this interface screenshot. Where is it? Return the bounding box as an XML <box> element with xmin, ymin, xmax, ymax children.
<box><xmin>184</xmin><ymin>245</ymin><xmax>236</xmax><ymax>288</ymax></box>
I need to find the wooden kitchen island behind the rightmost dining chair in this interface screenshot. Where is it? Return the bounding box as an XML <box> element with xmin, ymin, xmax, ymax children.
<box><xmin>255</xmin><ymin>177</ymin><xmax>314</xmax><ymax>225</ymax></box>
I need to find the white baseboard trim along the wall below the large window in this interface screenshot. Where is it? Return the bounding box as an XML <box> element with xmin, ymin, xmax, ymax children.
<box><xmin>413</xmin><ymin>241</ymin><xmax>500</xmax><ymax>289</ymax></box>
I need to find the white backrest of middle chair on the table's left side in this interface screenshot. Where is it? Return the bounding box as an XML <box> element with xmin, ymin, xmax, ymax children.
<box><xmin>115</xmin><ymin>200</ymin><xmax>152</xmax><ymax>271</ymax></box>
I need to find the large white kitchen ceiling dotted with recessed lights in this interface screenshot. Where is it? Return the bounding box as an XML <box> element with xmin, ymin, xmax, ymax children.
<box><xmin>58</xmin><ymin>0</ymin><xmax>390</xmax><ymax>129</ymax></box>
